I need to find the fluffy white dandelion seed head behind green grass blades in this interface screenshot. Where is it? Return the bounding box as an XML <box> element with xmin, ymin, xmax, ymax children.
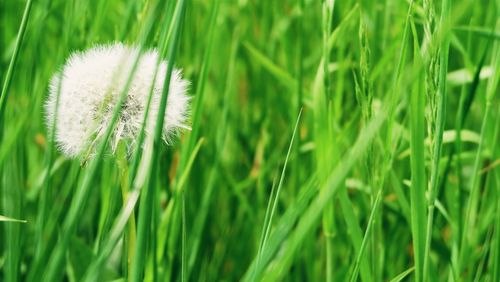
<box><xmin>45</xmin><ymin>43</ymin><xmax>189</xmax><ymax>157</ymax></box>
